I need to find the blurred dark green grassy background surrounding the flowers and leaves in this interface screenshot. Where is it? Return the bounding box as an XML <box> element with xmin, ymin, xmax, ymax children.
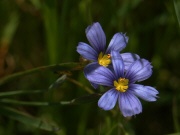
<box><xmin>0</xmin><ymin>0</ymin><xmax>180</xmax><ymax>135</ymax></box>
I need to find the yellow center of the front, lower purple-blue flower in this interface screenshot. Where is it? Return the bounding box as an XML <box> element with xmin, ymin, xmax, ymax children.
<box><xmin>114</xmin><ymin>78</ymin><xmax>129</xmax><ymax>92</ymax></box>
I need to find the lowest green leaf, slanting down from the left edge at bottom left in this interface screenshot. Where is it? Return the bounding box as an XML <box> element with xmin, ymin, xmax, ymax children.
<box><xmin>0</xmin><ymin>106</ymin><xmax>59</xmax><ymax>131</ymax></box>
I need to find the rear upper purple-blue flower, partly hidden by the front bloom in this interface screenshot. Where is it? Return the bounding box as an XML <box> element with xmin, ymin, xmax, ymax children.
<box><xmin>77</xmin><ymin>22</ymin><xmax>139</xmax><ymax>88</ymax></box>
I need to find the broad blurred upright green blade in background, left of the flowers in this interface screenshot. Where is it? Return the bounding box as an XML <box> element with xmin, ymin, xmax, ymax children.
<box><xmin>42</xmin><ymin>0</ymin><xmax>60</xmax><ymax>64</ymax></box>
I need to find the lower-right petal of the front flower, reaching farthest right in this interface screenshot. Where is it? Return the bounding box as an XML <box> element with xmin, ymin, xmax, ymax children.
<box><xmin>129</xmin><ymin>84</ymin><xmax>159</xmax><ymax>101</ymax></box>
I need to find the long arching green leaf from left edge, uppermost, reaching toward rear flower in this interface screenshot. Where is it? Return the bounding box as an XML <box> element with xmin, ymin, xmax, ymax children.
<box><xmin>0</xmin><ymin>62</ymin><xmax>82</xmax><ymax>85</ymax></box>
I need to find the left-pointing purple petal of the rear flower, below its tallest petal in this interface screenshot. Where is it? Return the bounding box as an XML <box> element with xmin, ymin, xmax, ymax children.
<box><xmin>77</xmin><ymin>42</ymin><xmax>98</xmax><ymax>61</ymax></box>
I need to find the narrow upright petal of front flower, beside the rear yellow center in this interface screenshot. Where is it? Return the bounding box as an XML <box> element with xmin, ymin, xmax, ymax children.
<box><xmin>111</xmin><ymin>51</ymin><xmax>124</xmax><ymax>79</ymax></box>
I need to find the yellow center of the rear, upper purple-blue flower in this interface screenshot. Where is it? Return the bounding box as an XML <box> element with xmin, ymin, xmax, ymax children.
<box><xmin>98</xmin><ymin>52</ymin><xmax>111</xmax><ymax>67</ymax></box>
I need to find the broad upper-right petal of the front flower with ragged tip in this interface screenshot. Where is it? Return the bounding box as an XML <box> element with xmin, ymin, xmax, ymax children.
<box><xmin>125</xmin><ymin>59</ymin><xmax>152</xmax><ymax>83</ymax></box>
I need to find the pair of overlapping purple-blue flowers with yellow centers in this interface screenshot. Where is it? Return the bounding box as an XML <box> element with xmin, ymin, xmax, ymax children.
<box><xmin>77</xmin><ymin>22</ymin><xmax>158</xmax><ymax>117</ymax></box>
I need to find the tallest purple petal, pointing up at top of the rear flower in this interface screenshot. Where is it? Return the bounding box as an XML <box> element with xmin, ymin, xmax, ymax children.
<box><xmin>86</xmin><ymin>22</ymin><xmax>106</xmax><ymax>53</ymax></box>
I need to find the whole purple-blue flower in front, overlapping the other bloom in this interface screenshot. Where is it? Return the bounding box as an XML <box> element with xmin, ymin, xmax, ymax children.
<box><xmin>85</xmin><ymin>51</ymin><xmax>158</xmax><ymax>117</ymax></box>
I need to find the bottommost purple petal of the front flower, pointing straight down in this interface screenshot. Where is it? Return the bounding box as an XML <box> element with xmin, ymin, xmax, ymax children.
<box><xmin>118</xmin><ymin>91</ymin><xmax>142</xmax><ymax>117</ymax></box>
